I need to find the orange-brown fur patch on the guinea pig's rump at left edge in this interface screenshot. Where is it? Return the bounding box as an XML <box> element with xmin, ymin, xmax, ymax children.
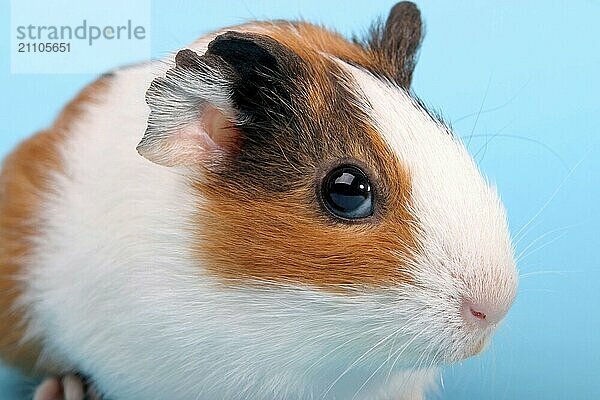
<box><xmin>0</xmin><ymin>78</ymin><xmax>108</xmax><ymax>375</ymax></box>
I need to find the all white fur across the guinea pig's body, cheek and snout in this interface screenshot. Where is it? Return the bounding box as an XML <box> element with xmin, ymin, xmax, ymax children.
<box><xmin>16</xmin><ymin>25</ymin><xmax>515</xmax><ymax>400</ymax></box>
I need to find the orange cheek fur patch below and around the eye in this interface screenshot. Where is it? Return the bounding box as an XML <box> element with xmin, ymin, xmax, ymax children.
<box><xmin>195</xmin><ymin>128</ymin><xmax>418</xmax><ymax>287</ymax></box>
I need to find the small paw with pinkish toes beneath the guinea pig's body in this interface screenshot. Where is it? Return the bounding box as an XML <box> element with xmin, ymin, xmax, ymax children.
<box><xmin>33</xmin><ymin>374</ymin><xmax>101</xmax><ymax>400</ymax></box>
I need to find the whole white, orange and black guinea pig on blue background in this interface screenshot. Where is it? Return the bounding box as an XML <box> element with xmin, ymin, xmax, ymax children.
<box><xmin>0</xmin><ymin>2</ymin><xmax>517</xmax><ymax>400</ymax></box>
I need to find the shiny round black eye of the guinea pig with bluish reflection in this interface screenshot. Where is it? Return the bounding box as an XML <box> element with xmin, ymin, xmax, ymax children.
<box><xmin>321</xmin><ymin>165</ymin><xmax>373</xmax><ymax>219</ymax></box>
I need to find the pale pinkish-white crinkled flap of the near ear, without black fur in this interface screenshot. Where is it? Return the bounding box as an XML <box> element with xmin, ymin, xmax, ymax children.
<box><xmin>137</xmin><ymin>49</ymin><xmax>239</xmax><ymax>167</ymax></box>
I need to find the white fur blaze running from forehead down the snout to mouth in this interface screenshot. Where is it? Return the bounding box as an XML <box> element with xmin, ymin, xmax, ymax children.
<box><xmin>345</xmin><ymin>65</ymin><xmax>517</xmax><ymax>361</ymax></box>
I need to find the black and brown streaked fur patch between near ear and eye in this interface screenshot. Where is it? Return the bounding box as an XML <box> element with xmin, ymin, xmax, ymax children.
<box><xmin>200</xmin><ymin>32</ymin><xmax>390</xmax><ymax>194</ymax></box>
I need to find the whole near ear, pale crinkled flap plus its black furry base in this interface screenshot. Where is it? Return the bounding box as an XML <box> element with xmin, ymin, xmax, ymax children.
<box><xmin>137</xmin><ymin>32</ymin><xmax>298</xmax><ymax>168</ymax></box>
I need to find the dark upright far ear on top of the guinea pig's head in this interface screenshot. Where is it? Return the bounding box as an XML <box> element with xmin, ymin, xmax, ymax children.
<box><xmin>367</xmin><ymin>1</ymin><xmax>423</xmax><ymax>89</ymax></box>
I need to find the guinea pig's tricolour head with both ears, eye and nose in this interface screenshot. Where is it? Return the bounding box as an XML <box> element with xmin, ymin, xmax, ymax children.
<box><xmin>138</xmin><ymin>4</ymin><xmax>517</xmax><ymax>364</ymax></box>
